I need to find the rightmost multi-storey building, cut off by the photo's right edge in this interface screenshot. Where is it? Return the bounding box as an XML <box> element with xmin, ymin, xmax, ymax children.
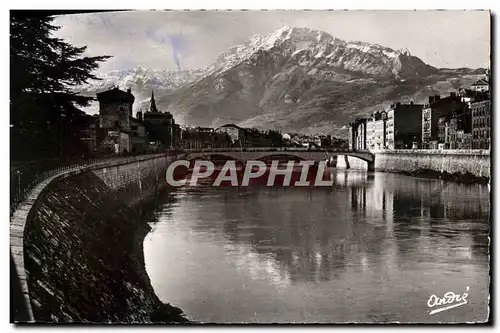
<box><xmin>471</xmin><ymin>98</ymin><xmax>491</xmax><ymax>149</ymax></box>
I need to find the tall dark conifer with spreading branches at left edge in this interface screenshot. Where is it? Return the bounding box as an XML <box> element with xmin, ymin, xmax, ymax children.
<box><xmin>10</xmin><ymin>14</ymin><xmax>109</xmax><ymax>159</ymax></box>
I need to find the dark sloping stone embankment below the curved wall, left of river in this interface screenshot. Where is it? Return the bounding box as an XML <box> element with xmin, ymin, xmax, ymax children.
<box><xmin>20</xmin><ymin>172</ymin><xmax>187</xmax><ymax>323</ymax></box>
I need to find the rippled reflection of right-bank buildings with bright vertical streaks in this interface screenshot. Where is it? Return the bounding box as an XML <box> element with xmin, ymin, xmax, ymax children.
<box><xmin>349</xmin><ymin>175</ymin><xmax>488</xmax><ymax>265</ymax></box>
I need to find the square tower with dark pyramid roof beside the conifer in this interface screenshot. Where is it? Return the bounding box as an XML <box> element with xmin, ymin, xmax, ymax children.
<box><xmin>97</xmin><ymin>87</ymin><xmax>135</xmax><ymax>154</ymax></box>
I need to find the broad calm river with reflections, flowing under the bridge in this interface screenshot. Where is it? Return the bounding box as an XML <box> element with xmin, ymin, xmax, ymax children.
<box><xmin>144</xmin><ymin>170</ymin><xmax>489</xmax><ymax>323</ymax></box>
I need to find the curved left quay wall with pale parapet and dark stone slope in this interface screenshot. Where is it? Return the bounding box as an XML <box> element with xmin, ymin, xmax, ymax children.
<box><xmin>11</xmin><ymin>155</ymin><xmax>186</xmax><ymax>323</ymax></box>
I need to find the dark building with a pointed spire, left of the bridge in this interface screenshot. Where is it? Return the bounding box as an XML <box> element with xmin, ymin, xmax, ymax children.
<box><xmin>143</xmin><ymin>92</ymin><xmax>181</xmax><ymax>149</ymax></box>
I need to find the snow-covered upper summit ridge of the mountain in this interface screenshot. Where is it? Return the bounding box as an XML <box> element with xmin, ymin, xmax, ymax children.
<box><xmin>210</xmin><ymin>26</ymin><xmax>436</xmax><ymax>77</ymax></box>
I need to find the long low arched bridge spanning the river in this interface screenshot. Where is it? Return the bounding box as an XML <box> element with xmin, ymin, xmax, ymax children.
<box><xmin>177</xmin><ymin>147</ymin><xmax>375</xmax><ymax>170</ymax></box>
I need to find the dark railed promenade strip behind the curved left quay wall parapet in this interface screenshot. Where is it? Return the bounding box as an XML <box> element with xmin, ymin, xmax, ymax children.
<box><xmin>10</xmin><ymin>154</ymin><xmax>168</xmax><ymax>215</ymax></box>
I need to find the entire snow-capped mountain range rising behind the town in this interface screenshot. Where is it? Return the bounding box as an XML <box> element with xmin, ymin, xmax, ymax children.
<box><xmin>78</xmin><ymin>26</ymin><xmax>484</xmax><ymax>135</ymax></box>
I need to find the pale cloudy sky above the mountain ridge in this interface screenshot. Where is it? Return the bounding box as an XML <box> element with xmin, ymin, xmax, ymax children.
<box><xmin>54</xmin><ymin>10</ymin><xmax>490</xmax><ymax>73</ymax></box>
